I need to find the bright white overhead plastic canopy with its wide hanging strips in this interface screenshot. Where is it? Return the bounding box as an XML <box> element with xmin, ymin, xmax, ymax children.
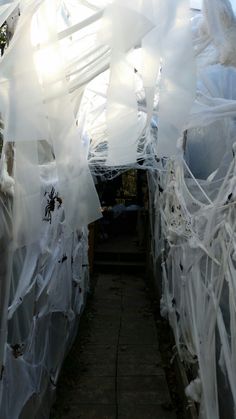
<box><xmin>0</xmin><ymin>0</ymin><xmax>195</xmax><ymax>246</ymax></box>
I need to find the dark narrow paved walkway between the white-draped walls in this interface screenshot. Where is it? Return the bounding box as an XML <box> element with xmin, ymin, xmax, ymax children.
<box><xmin>51</xmin><ymin>274</ymin><xmax>176</xmax><ymax>419</ymax></box>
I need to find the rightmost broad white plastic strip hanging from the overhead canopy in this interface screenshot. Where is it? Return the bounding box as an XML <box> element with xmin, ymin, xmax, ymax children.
<box><xmin>158</xmin><ymin>0</ymin><xmax>196</xmax><ymax>157</ymax></box>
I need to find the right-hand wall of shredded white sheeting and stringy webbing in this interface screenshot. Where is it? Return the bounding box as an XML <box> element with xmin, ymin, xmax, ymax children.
<box><xmin>150</xmin><ymin>0</ymin><xmax>236</xmax><ymax>419</ymax></box>
